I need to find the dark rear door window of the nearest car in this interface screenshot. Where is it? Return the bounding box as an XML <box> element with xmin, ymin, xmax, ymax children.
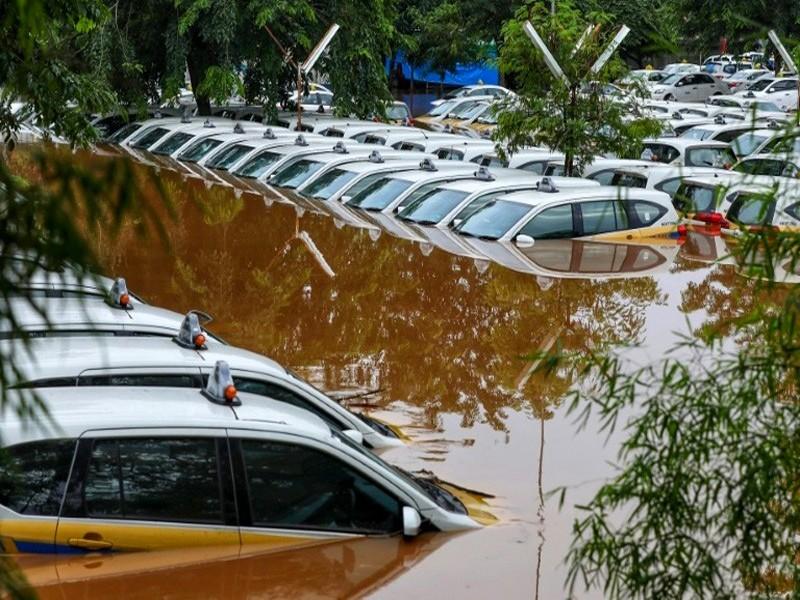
<box><xmin>62</xmin><ymin>437</ymin><xmax>225</xmax><ymax>524</ymax></box>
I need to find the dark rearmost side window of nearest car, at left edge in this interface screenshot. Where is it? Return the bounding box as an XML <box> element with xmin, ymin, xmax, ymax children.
<box><xmin>0</xmin><ymin>440</ymin><xmax>75</xmax><ymax>517</ymax></box>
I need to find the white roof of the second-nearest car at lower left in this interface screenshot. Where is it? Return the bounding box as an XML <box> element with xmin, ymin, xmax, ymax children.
<box><xmin>5</xmin><ymin>336</ymin><xmax>287</xmax><ymax>381</ymax></box>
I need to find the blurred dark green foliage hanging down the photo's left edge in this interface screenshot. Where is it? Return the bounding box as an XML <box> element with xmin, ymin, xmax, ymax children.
<box><xmin>0</xmin><ymin>0</ymin><xmax>170</xmax><ymax>598</ymax></box>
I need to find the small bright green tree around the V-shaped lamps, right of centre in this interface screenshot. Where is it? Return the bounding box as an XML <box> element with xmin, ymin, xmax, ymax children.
<box><xmin>495</xmin><ymin>0</ymin><xmax>660</xmax><ymax>175</ymax></box>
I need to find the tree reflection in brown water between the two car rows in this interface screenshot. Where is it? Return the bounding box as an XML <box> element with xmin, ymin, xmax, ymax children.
<box><xmin>100</xmin><ymin>172</ymin><xmax>663</xmax><ymax>430</ymax></box>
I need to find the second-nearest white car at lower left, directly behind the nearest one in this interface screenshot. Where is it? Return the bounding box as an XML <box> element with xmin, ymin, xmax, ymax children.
<box><xmin>1</xmin><ymin>328</ymin><xmax>403</xmax><ymax>449</ymax></box>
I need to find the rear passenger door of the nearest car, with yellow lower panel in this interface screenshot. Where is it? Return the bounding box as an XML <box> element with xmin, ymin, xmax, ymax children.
<box><xmin>55</xmin><ymin>429</ymin><xmax>240</xmax><ymax>553</ymax></box>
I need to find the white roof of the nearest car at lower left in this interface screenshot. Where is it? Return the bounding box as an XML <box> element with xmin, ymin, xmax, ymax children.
<box><xmin>0</xmin><ymin>386</ymin><xmax>331</xmax><ymax>445</ymax></box>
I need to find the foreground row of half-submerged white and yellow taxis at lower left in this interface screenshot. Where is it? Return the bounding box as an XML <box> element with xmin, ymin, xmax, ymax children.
<box><xmin>0</xmin><ymin>251</ymin><xmax>494</xmax><ymax>554</ymax></box>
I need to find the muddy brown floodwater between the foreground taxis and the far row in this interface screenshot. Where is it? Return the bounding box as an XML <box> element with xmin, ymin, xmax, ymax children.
<box><xmin>6</xmin><ymin>156</ymin><xmax>764</xmax><ymax>600</ymax></box>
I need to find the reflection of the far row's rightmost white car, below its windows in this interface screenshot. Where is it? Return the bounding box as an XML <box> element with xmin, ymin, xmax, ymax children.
<box><xmin>456</xmin><ymin>238</ymin><xmax>680</xmax><ymax>279</ymax></box>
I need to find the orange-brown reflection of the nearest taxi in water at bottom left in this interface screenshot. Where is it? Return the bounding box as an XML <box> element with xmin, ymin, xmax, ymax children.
<box><xmin>15</xmin><ymin>534</ymin><xmax>450</xmax><ymax>600</ymax></box>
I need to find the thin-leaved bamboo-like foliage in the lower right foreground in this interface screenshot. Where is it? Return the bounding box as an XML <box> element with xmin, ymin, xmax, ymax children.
<box><xmin>550</xmin><ymin>224</ymin><xmax>800</xmax><ymax>598</ymax></box>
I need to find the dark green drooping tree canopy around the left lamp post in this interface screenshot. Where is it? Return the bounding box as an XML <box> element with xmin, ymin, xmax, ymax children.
<box><xmin>98</xmin><ymin>0</ymin><xmax>395</xmax><ymax>117</ymax></box>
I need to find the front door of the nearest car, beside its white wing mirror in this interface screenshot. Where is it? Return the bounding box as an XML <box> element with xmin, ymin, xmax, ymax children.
<box><xmin>228</xmin><ymin>430</ymin><xmax>409</xmax><ymax>548</ymax></box>
